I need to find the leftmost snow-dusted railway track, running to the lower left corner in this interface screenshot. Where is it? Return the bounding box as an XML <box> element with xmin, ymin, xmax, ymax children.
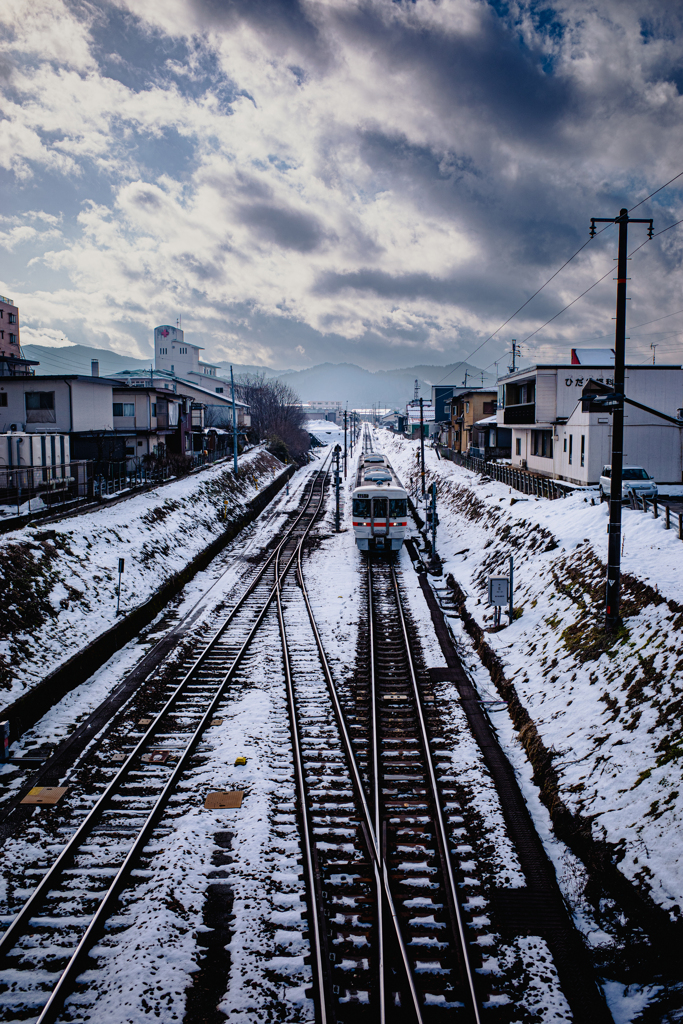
<box><xmin>0</xmin><ymin>461</ymin><xmax>329</xmax><ymax>1024</ymax></box>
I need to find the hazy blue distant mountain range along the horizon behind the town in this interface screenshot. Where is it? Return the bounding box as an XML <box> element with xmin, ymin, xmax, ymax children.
<box><xmin>22</xmin><ymin>345</ymin><xmax>496</xmax><ymax>409</ymax></box>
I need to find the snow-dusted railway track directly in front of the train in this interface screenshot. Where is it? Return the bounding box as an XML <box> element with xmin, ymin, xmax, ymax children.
<box><xmin>358</xmin><ymin>559</ymin><xmax>490</xmax><ymax>1024</ymax></box>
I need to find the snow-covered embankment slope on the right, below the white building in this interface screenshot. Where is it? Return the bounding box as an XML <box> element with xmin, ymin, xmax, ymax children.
<box><xmin>377</xmin><ymin>431</ymin><xmax>683</xmax><ymax>915</ymax></box>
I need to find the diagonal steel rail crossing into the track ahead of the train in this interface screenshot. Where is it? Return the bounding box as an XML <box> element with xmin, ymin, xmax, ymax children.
<box><xmin>297</xmin><ymin>516</ymin><xmax>423</xmax><ymax>1024</ymax></box>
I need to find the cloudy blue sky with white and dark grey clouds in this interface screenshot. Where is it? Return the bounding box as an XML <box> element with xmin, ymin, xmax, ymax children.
<box><xmin>0</xmin><ymin>0</ymin><xmax>683</xmax><ymax>370</ymax></box>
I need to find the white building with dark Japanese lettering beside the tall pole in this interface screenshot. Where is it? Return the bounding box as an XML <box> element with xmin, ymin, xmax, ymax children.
<box><xmin>497</xmin><ymin>360</ymin><xmax>683</xmax><ymax>485</ymax></box>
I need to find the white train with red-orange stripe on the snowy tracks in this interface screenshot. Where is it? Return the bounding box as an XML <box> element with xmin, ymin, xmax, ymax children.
<box><xmin>352</xmin><ymin>452</ymin><xmax>408</xmax><ymax>551</ymax></box>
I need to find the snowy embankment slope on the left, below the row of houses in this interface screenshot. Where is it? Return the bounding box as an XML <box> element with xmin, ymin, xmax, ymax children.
<box><xmin>0</xmin><ymin>447</ymin><xmax>284</xmax><ymax>710</ymax></box>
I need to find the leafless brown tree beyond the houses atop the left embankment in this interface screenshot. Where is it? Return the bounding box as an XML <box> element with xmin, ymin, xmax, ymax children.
<box><xmin>238</xmin><ymin>374</ymin><xmax>310</xmax><ymax>462</ymax></box>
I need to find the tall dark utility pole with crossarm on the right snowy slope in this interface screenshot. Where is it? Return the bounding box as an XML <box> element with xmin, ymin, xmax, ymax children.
<box><xmin>591</xmin><ymin>209</ymin><xmax>653</xmax><ymax>633</ymax></box>
